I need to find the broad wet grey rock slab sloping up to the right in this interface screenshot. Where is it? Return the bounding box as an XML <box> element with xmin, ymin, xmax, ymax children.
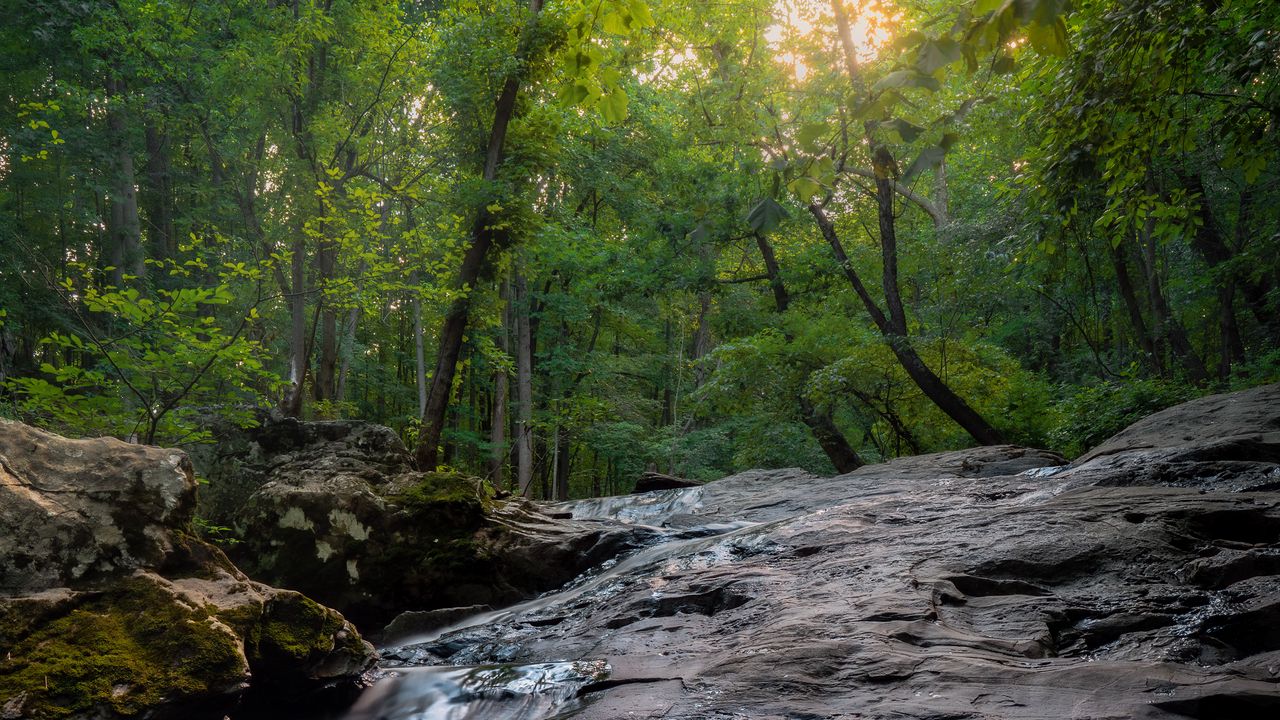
<box><xmin>373</xmin><ymin>386</ymin><xmax>1280</xmax><ymax>720</ymax></box>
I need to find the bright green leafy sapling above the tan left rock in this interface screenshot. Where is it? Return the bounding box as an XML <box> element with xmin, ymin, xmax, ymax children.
<box><xmin>9</xmin><ymin>245</ymin><xmax>274</xmax><ymax>445</ymax></box>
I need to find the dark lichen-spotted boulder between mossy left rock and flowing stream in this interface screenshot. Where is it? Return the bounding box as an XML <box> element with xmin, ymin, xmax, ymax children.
<box><xmin>224</xmin><ymin>420</ymin><xmax>653</xmax><ymax>628</ymax></box>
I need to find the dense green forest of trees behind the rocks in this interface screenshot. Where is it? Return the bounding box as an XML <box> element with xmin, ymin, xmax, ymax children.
<box><xmin>0</xmin><ymin>0</ymin><xmax>1280</xmax><ymax>498</ymax></box>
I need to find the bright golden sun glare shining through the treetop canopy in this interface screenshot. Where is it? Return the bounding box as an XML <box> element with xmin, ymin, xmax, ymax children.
<box><xmin>764</xmin><ymin>0</ymin><xmax>902</xmax><ymax>82</ymax></box>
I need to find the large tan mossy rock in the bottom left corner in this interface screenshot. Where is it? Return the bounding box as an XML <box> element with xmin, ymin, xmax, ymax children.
<box><xmin>0</xmin><ymin>420</ymin><xmax>372</xmax><ymax>720</ymax></box>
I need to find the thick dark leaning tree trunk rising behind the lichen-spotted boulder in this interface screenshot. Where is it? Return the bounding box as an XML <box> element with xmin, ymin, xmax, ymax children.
<box><xmin>415</xmin><ymin>0</ymin><xmax>543</xmax><ymax>470</ymax></box>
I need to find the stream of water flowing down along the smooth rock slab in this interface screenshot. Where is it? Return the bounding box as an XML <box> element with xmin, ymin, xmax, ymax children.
<box><xmin>344</xmin><ymin>491</ymin><xmax>772</xmax><ymax>720</ymax></box>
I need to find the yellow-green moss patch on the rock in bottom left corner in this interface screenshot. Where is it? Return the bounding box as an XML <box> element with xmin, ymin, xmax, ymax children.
<box><xmin>0</xmin><ymin>578</ymin><xmax>246</xmax><ymax>720</ymax></box>
